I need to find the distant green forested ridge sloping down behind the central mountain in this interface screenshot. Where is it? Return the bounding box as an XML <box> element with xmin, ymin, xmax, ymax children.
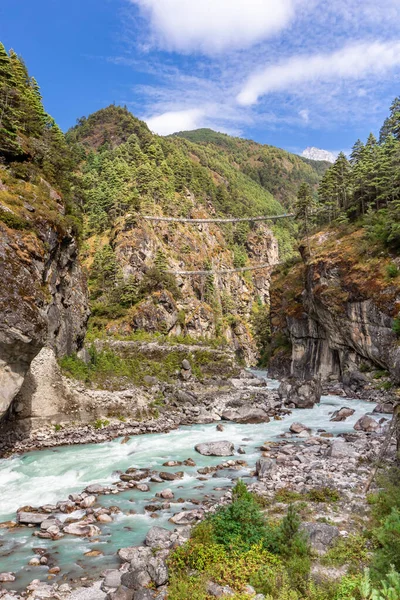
<box><xmin>174</xmin><ymin>129</ymin><xmax>330</xmax><ymax>208</ymax></box>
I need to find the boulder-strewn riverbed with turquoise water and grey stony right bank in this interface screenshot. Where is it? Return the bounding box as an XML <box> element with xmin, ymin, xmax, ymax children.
<box><xmin>0</xmin><ymin>370</ymin><xmax>394</xmax><ymax>600</ymax></box>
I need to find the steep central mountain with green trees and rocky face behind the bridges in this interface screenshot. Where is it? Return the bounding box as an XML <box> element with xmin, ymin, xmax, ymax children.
<box><xmin>67</xmin><ymin>106</ymin><xmax>306</xmax><ymax>363</ymax></box>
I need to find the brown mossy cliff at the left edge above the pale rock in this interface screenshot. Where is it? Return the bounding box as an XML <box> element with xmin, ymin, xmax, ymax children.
<box><xmin>0</xmin><ymin>169</ymin><xmax>88</xmax><ymax>417</ymax></box>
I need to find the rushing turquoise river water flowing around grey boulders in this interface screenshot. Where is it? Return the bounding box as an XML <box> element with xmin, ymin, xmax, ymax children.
<box><xmin>0</xmin><ymin>371</ymin><xmax>388</xmax><ymax>589</ymax></box>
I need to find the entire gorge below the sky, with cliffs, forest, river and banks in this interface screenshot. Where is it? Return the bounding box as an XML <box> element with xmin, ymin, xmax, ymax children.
<box><xmin>0</xmin><ymin>44</ymin><xmax>400</xmax><ymax>600</ymax></box>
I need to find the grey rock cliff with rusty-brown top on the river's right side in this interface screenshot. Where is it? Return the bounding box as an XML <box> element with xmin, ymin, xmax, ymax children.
<box><xmin>271</xmin><ymin>231</ymin><xmax>400</xmax><ymax>383</ymax></box>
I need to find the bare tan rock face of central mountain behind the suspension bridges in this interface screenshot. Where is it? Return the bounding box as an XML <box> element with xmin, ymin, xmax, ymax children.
<box><xmin>97</xmin><ymin>199</ymin><xmax>279</xmax><ymax>364</ymax></box>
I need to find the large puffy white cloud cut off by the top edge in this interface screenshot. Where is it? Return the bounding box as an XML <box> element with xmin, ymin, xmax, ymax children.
<box><xmin>130</xmin><ymin>0</ymin><xmax>297</xmax><ymax>54</ymax></box>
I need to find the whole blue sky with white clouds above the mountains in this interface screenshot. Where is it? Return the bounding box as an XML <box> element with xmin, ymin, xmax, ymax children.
<box><xmin>0</xmin><ymin>0</ymin><xmax>400</xmax><ymax>152</ymax></box>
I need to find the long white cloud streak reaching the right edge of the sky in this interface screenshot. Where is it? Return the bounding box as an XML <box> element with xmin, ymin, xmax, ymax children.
<box><xmin>237</xmin><ymin>40</ymin><xmax>400</xmax><ymax>106</ymax></box>
